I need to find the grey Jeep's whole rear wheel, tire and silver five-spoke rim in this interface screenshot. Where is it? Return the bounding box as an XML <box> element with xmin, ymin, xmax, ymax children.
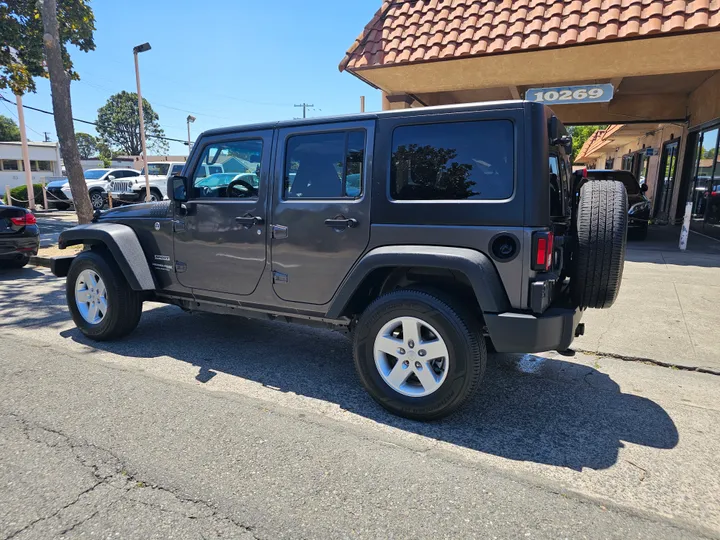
<box><xmin>353</xmin><ymin>289</ymin><xmax>487</xmax><ymax>420</ymax></box>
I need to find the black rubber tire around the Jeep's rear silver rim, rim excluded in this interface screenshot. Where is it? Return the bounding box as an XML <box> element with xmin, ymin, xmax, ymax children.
<box><xmin>353</xmin><ymin>289</ymin><xmax>487</xmax><ymax>421</ymax></box>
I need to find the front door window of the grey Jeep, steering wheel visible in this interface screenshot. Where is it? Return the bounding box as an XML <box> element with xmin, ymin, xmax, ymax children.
<box><xmin>192</xmin><ymin>139</ymin><xmax>263</xmax><ymax>199</ymax></box>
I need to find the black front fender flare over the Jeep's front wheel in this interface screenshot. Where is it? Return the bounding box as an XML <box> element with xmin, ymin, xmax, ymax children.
<box><xmin>55</xmin><ymin>223</ymin><xmax>155</xmax><ymax>291</ymax></box>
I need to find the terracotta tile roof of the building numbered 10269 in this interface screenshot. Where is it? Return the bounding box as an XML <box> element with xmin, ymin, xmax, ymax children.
<box><xmin>340</xmin><ymin>0</ymin><xmax>720</xmax><ymax>70</ymax></box>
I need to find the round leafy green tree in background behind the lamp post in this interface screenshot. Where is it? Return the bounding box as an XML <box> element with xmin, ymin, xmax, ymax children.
<box><xmin>96</xmin><ymin>91</ymin><xmax>169</xmax><ymax>156</ymax></box>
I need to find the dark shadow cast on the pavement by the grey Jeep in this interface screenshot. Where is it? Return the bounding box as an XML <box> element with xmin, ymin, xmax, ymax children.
<box><xmin>61</xmin><ymin>306</ymin><xmax>678</xmax><ymax>470</ymax></box>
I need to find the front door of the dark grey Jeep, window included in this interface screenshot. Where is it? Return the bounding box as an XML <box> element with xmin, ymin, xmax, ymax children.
<box><xmin>174</xmin><ymin>130</ymin><xmax>273</xmax><ymax>295</ymax></box>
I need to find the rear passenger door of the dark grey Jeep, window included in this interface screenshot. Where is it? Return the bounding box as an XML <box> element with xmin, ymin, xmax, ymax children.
<box><xmin>271</xmin><ymin>121</ymin><xmax>375</xmax><ymax>305</ymax></box>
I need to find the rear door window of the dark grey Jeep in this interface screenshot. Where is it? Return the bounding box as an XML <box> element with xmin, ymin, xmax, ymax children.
<box><xmin>283</xmin><ymin>131</ymin><xmax>365</xmax><ymax>199</ymax></box>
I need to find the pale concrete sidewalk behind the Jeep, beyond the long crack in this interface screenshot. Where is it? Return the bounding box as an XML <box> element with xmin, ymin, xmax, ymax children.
<box><xmin>573</xmin><ymin>227</ymin><xmax>720</xmax><ymax>374</ymax></box>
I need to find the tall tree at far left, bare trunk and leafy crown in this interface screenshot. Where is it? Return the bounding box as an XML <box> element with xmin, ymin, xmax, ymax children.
<box><xmin>0</xmin><ymin>0</ymin><xmax>95</xmax><ymax>223</ymax></box>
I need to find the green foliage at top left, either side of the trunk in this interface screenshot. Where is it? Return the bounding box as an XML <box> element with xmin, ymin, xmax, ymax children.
<box><xmin>0</xmin><ymin>0</ymin><xmax>95</xmax><ymax>94</ymax></box>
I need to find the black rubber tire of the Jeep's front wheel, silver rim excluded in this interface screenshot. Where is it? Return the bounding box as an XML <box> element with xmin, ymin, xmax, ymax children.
<box><xmin>66</xmin><ymin>251</ymin><xmax>142</xmax><ymax>341</ymax></box>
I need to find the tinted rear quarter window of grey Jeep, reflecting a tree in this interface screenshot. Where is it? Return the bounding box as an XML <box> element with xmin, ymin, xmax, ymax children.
<box><xmin>390</xmin><ymin>120</ymin><xmax>514</xmax><ymax>200</ymax></box>
